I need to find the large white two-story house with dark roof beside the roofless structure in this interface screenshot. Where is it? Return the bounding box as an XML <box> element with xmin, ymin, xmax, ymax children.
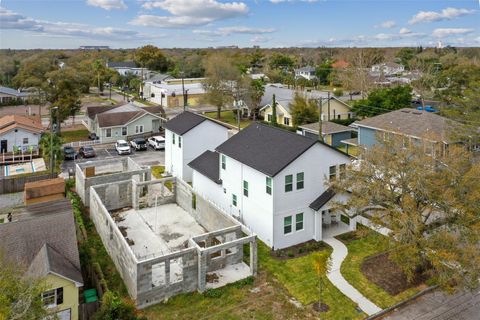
<box><xmin>189</xmin><ymin>123</ymin><xmax>350</xmax><ymax>249</ymax></box>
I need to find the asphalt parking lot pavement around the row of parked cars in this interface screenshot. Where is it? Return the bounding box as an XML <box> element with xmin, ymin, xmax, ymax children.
<box><xmin>61</xmin><ymin>144</ymin><xmax>165</xmax><ymax>176</ymax></box>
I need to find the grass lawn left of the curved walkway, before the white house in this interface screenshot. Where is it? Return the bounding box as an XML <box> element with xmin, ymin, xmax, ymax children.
<box><xmin>258</xmin><ymin>243</ymin><xmax>365</xmax><ymax>320</ymax></box>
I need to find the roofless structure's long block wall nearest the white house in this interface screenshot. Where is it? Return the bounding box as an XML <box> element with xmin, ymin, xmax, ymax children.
<box><xmin>175</xmin><ymin>179</ymin><xmax>235</xmax><ymax>231</ymax></box>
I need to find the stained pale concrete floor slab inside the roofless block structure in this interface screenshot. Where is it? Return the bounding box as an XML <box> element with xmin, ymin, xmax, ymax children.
<box><xmin>118</xmin><ymin>203</ymin><xmax>207</xmax><ymax>259</ymax></box>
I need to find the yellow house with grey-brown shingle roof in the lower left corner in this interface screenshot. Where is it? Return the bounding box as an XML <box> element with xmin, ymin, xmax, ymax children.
<box><xmin>0</xmin><ymin>199</ymin><xmax>83</xmax><ymax>320</ymax></box>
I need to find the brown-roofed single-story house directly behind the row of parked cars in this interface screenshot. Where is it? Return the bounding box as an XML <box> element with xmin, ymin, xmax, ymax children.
<box><xmin>84</xmin><ymin>103</ymin><xmax>163</xmax><ymax>142</ymax></box>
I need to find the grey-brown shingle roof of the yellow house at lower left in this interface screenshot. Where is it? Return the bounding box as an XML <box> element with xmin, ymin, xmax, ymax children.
<box><xmin>0</xmin><ymin>199</ymin><xmax>83</xmax><ymax>283</ymax></box>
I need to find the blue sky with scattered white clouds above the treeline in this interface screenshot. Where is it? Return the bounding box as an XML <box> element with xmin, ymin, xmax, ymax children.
<box><xmin>0</xmin><ymin>0</ymin><xmax>480</xmax><ymax>49</ymax></box>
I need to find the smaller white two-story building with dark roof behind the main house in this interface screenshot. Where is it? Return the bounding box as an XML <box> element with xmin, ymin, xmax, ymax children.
<box><xmin>164</xmin><ymin>111</ymin><xmax>229</xmax><ymax>182</ymax></box>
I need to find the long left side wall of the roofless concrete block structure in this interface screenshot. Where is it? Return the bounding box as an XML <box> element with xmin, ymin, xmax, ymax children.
<box><xmin>90</xmin><ymin>187</ymin><xmax>137</xmax><ymax>299</ymax></box>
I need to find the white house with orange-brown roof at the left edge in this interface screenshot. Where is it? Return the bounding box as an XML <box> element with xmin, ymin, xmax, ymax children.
<box><xmin>0</xmin><ymin>115</ymin><xmax>43</xmax><ymax>153</ymax></box>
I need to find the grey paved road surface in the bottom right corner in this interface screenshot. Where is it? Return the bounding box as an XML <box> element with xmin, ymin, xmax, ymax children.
<box><xmin>383</xmin><ymin>290</ymin><xmax>480</xmax><ymax>320</ymax></box>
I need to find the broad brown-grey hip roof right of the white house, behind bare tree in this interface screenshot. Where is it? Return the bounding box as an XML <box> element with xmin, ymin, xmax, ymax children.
<box><xmin>354</xmin><ymin>108</ymin><xmax>454</xmax><ymax>142</ymax></box>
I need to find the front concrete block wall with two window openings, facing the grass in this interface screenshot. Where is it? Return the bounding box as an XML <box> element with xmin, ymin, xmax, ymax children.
<box><xmin>137</xmin><ymin>248</ymin><xmax>198</xmax><ymax>308</ymax></box>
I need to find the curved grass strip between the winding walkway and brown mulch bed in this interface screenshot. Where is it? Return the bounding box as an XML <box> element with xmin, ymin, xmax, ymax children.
<box><xmin>338</xmin><ymin>230</ymin><xmax>425</xmax><ymax>308</ymax></box>
